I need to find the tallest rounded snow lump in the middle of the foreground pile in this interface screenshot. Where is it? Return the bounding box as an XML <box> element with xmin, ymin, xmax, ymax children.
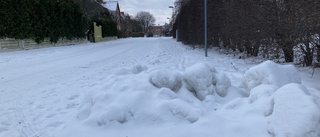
<box><xmin>183</xmin><ymin>63</ymin><xmax>214</xmax><ymax>100</ymax></box>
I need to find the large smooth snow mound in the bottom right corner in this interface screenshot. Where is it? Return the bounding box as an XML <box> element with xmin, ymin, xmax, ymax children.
<box><xmin>268</xmin><ymin>83</ymin><xmax>320</xmax><ymax>137</ymax></box>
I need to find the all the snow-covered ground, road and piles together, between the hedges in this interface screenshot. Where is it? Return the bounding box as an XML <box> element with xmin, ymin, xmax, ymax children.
<box><xmin>0</xmin><ymin>38</ymin><xmax>320</xmax><ymax>137</ymax></box>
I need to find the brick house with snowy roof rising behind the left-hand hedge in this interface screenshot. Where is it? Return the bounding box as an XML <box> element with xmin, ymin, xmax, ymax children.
<box><xmin>101</xmin><ymin>0</ymin><xmax>121</xmax><ymax>31</ymax></box>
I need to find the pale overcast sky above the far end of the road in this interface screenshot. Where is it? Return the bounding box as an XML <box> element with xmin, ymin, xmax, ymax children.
<box><xmin>118</xmin><ymin>0</ymin><xmax>175</xmax><ymax>25</ymax></box>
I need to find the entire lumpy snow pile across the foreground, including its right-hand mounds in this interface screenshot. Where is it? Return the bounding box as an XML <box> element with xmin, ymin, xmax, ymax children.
<box><xmin>77</xmin><ymin>61</ymin><xmax>320</xmax><ymax>137</ymax></box>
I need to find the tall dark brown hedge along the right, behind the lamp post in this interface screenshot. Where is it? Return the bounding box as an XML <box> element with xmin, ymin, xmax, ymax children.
<box><xmin>173</xmin><ymin>0</ymin><xmax>320</xmax><ymax>66</ymax></box>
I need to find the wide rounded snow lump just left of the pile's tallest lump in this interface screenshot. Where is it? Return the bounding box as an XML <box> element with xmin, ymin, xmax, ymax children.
<box><xmin>149</xmin><ymin>69</ymin><xmax>182</xmax><ymax>91</ymax></box>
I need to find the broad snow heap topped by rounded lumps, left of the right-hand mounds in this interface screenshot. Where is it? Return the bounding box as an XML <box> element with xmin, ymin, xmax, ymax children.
<box><xmin>77</xmin><ymin>63</ymin><xmax>231</xmax><ymax>126</ymax></box>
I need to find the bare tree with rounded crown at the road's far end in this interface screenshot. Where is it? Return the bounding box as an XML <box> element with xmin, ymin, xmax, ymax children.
<box><xmin>136</xmin><ymin>11</ymin><xmax>156</xmax><ymax>33</ymax></box>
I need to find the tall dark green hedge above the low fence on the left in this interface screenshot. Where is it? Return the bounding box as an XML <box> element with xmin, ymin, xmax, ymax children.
<box><xmin>0</xmin><ymin>0</ymin><xmax>86</xmax><ymax>43</ymax></box>
